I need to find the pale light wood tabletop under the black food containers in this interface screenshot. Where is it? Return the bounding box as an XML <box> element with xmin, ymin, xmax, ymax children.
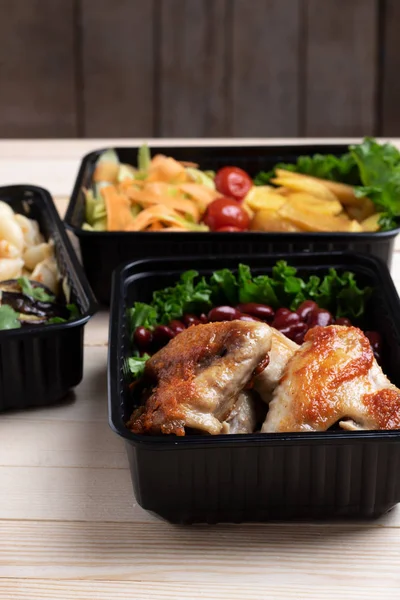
<box><xmin>0</xmin><ymin>140</ymin><xmax>400</xmax><ymax>600</ymax></box>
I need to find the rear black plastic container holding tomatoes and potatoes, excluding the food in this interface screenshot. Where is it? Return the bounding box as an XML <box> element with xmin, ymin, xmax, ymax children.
<box><xmin>65</xmin><ymin>144</ymin><xmax>400</xmax><ymax>304</ymax></box>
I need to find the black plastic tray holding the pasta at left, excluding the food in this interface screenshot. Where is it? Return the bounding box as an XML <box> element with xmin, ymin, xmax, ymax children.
<box><xmin>0</xmin><ymin>185</ymin><xmax>96</xmax><ymax>411</ymax></box>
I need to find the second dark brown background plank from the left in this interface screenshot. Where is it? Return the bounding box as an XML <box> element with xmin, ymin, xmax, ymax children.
<box><xmin>80</xmin><ymin>0</ymin><xmax>154</xmax><ymax>137</ymax></box>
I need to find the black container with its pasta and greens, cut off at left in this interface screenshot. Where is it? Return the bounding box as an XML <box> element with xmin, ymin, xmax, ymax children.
<box><xmin>0</xmin><ymin>185</ymin><xmax>96</xmax><ymax>412</ymax></box>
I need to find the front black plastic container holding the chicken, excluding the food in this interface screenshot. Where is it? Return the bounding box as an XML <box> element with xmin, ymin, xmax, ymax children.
<box><xmin>109</xmin><ymin>253</ymin><xmax>400</xmax><ymax>523</ymax></box>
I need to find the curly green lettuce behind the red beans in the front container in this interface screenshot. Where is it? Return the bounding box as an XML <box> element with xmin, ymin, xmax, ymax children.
<box><xmin>128</xmin><ymin>260</ymin><xmax>371</xmax><ymax>340</ymax></box>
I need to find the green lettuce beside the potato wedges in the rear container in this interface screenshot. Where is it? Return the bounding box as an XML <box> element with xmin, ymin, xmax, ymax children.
<box><xmin>254</xmin><ymin>137</ymin><xmax>400</xmax><ymax>230</ymax></box>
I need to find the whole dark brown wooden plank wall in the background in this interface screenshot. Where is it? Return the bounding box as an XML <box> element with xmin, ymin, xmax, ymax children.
<box><xmin>0</xmin><ymin>0</ymin><xmax>400</xmax><ymax>138</ymax></box>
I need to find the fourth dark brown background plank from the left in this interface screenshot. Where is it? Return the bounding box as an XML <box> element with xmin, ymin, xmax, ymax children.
<box><xmin>231</xmin><ymin>0</ymin><xmax>301</xmax><ymax>136</ymax></box>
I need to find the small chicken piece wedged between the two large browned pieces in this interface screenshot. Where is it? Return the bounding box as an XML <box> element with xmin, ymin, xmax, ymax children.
<box><xmin>254</xmin><ymin>329</ymin><xmax>300</xmax><ymax>404</ymax></box>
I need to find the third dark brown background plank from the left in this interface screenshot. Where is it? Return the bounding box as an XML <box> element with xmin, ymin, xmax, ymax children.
<box><xmin>157</xmin><ymin>0</ymin><xmax>231</xmax><ymax>137</ymax></box>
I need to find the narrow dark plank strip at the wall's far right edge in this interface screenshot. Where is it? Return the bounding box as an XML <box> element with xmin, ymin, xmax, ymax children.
<box><xmin>380</xmin><ymin>0</ymin><xmax>400</xmax><ymax>135</ymax></box>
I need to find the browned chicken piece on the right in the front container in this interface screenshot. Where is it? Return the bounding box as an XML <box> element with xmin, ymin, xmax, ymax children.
<box><xmin>262</xmin><ymin>325</ymin><xmax>400</xmax><ymax>433</ymax></box>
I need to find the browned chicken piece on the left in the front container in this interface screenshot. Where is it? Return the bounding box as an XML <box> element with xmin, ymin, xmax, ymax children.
<box><xmin>127</xmin><ymin>321</ymin><xmax>272</xmax><ymax>435</ymax></box>
